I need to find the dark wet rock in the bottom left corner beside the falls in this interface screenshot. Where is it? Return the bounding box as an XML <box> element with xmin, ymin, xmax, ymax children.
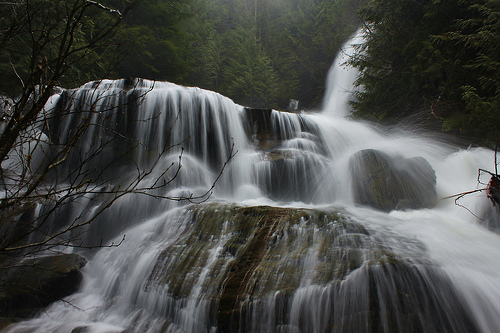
<box><xmin>0</xmin><ymin>254</ymin><xmax>87</xmax><ymax>318</ymax></box>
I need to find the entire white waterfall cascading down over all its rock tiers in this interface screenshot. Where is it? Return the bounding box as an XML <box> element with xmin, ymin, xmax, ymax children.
<box><xmin>1</xmin><ymin>32</ymin><xmax>500</xmax><ymax>333</ymax></box>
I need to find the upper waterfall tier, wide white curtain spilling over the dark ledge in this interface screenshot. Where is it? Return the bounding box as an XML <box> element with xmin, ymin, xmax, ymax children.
<box><xmin>41</xmin><ymin>79</ymin><xmax>448</xmax><ymax>210</ymax></box>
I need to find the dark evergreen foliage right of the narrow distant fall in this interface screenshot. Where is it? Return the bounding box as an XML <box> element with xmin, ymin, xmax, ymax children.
<box><xmin>351</xmin><ymin>0</ymin><xmax>500</xmax><ymax>142</ymax></box>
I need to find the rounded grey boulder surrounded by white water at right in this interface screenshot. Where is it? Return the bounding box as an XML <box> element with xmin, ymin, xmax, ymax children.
<box><xmin>349</xmin><ymin>149</ymin><xmax>437</xmax><ymax>211</ymax></box>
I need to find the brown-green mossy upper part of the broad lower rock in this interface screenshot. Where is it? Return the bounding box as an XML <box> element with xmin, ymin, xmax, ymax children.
<box><xmin>148</xmin><ymin>204</ymin><xmax>404</xmax><ymax>331</ymax></box>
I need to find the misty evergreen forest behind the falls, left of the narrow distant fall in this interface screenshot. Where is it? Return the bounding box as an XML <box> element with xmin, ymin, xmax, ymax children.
<box><xmin>0</xmin><ymin>0</ymin><xmax>364</xmax><ymax>108</ymax></box>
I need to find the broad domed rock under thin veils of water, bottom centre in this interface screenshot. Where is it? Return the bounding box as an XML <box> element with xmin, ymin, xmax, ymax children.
<box><xmin>147</xmin><ymin>204</ymin><xmax>478</xmax><ymax>332</ymax></box>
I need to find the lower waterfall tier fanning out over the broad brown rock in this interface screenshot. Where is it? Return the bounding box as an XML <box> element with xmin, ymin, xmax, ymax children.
<box><xmin>3</xmin><ymin>203</ymin><xmax>480</xmax><ymax>333</ymax></box>
